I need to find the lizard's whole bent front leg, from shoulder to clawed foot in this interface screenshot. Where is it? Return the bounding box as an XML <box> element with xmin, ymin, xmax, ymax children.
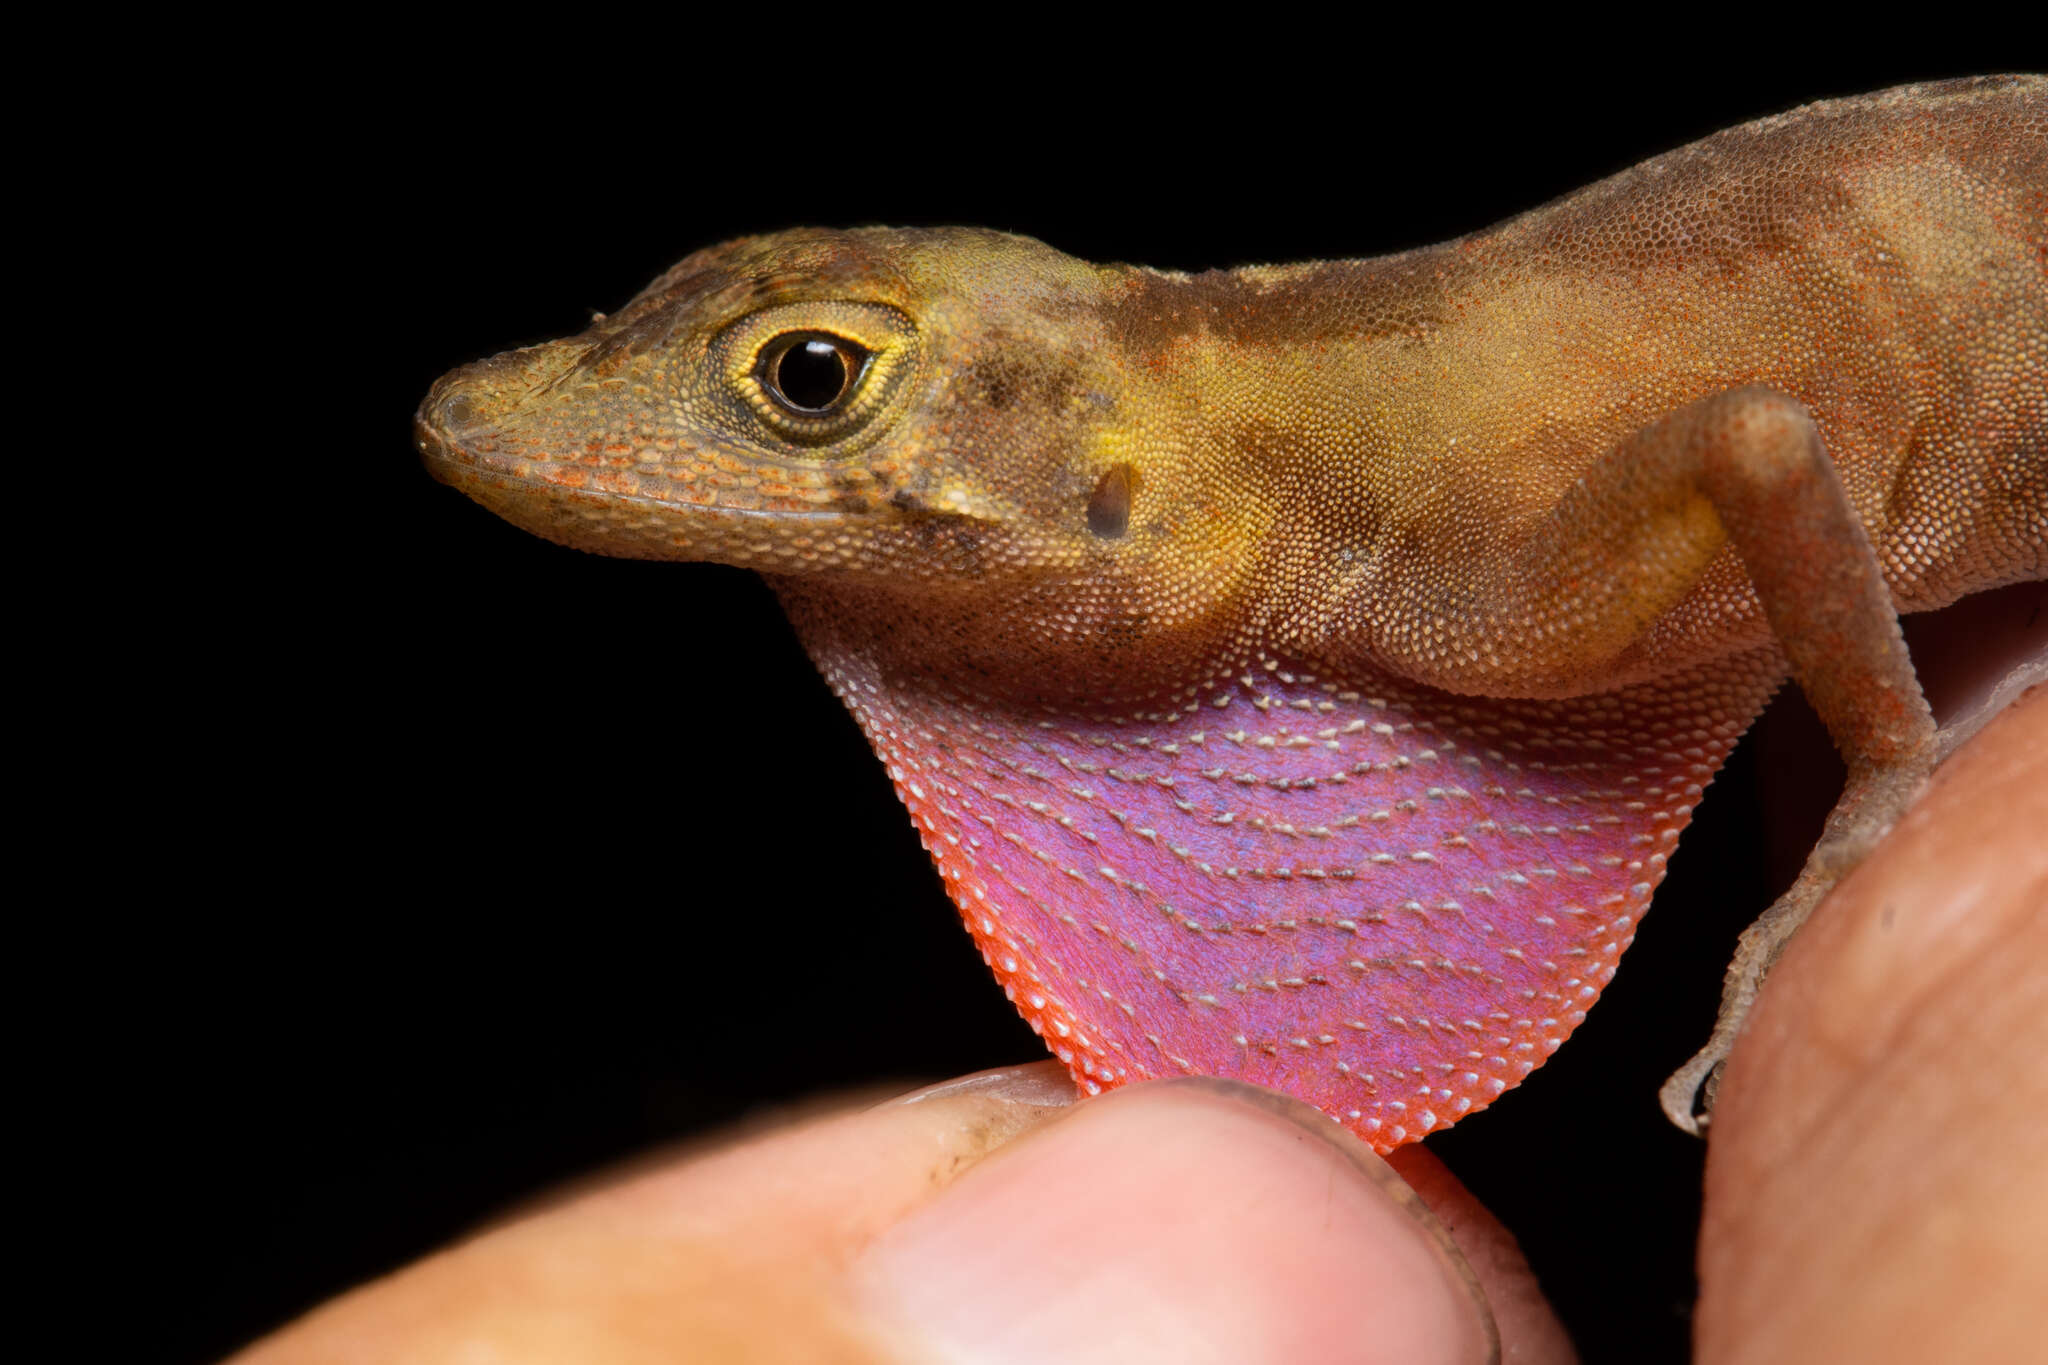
<box><xmin>1310</xmin><ymin>389</ymin><xmax>1935</xmax><ymax>1132</ymax></box>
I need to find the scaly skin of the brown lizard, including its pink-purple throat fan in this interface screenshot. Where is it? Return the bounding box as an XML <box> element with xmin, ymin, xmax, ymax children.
<box><xmin>418</xmin><ymin>78</ymin><xmax>2048</xmax><ymax>1150</ymax></box>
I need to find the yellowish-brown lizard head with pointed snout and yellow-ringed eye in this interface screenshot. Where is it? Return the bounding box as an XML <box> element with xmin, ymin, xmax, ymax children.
<box><xmin>416</xmin><ymin>229</ymin><xmax>1262</xmax><ymax>687</ymax></box>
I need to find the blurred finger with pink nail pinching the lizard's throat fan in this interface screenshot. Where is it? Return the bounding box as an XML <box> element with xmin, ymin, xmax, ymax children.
<box><xmin>246</xmin><ymin>1066</ymin><xmax>1569</xmax><ymax>1365</ymax></box>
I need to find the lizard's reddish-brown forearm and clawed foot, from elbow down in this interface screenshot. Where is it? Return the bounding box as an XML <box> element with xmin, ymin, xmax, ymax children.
<box><xmin>1659</xmin><ymin>389</ymin><xmax>1935</xmax><ymax>1134</ymax></box>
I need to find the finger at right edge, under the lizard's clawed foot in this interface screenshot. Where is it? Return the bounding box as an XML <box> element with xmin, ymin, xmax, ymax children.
<box><xmin>1696</xmin><ymin>688</ymin><xmax>2048</xmax><ymax>1361</ymax></box>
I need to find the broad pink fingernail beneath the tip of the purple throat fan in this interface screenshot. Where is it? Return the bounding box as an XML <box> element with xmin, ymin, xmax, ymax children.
<box><xmin>856</xmin><ymin>1081</ymin><xmax>1497</xmax><ymax>1365</ymax></box>
